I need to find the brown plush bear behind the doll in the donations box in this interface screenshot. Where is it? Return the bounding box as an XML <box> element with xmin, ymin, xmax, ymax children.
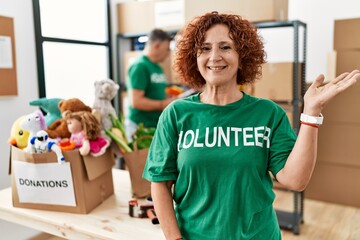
<box><xmin>46</xmin><ymin>98</ymin><xmax>92</xmax><ymax>139</ymax></box>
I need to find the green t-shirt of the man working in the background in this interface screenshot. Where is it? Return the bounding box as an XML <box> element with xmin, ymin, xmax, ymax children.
<box><xmin>127</xmin><ymin>55</ymin><xmax>167</xmax><ymax>127</ymax></box>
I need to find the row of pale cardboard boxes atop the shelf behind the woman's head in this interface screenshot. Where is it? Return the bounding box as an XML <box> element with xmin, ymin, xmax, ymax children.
<box><xmin>117</xmin><ymin>0</ymin><xmax>288</xmax><ymax>34</ymax></box>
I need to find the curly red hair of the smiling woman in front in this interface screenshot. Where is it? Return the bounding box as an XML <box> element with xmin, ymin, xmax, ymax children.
<box><xmin>173</xmin><ymin>12</ymin><xmax>266</xmax><ymax>89</ymax></box>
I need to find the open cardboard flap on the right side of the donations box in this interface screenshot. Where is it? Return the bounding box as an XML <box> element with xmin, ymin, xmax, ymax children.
<box><xmin>83</xmin><ymin>148</ymin><xmax>115</xmax><ymax>181</ymax></box>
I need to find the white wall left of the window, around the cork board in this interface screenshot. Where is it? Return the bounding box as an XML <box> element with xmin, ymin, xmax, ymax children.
<box><xmin>0</xmin><ymin>0</ymin><xmax>39</xmax><ymax>239</ymax></box>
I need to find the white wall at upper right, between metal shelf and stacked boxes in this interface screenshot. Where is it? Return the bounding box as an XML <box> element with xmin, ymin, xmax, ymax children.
<box><xmin>289</xmin><ymin>0</ymin><xmax>360</xmax><ymax>82</ymax></box>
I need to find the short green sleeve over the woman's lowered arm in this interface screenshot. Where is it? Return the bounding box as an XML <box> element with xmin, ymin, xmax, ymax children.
<box><xmin>143</xmin><ymin>106</ymin><xmax>179</xmax><ymax>182</ymax></box>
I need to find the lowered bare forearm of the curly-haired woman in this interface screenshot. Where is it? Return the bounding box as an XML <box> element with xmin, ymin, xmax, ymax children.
<box><xmin>151</xmin><ymin>182</ymin><xmax>181</xmax><ymax>240</ymax></box>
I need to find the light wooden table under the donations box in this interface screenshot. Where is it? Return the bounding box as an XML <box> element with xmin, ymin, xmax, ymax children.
<box><xmin>0</xmin><ymin>169</ymin><xmax>164</xmax><ymax>240</ymax></box>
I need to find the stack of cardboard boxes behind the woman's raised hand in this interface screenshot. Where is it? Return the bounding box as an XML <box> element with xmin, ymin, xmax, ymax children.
<box><xmin>306</xmin><ymin>18</ymin><xmax>360</xmax><ymax>207</ymax></box>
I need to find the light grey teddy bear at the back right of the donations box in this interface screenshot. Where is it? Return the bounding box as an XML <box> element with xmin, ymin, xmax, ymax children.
<box><xmin>93</xmin><ymin>79</ymin><xmax>119</xmax><ymax>130</ymax></box>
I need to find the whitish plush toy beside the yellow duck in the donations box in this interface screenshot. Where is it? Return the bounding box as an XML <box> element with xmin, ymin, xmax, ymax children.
<box><xmin>20</xmin><ymin>110</ymin><xmax>46</xmax><ymax>152</ymax></box>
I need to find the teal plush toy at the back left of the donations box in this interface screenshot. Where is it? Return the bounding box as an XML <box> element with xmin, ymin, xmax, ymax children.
<box><xmin>29</xmin><ymin>98</ymin><xmax>62</xmax><ymax>126</ymax></box>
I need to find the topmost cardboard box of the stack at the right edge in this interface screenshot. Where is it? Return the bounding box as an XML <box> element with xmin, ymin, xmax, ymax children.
<box><xmin>334</xmin><ymin>18</ymin><xmax>360</xmax><ymax>50</ymax></box>
